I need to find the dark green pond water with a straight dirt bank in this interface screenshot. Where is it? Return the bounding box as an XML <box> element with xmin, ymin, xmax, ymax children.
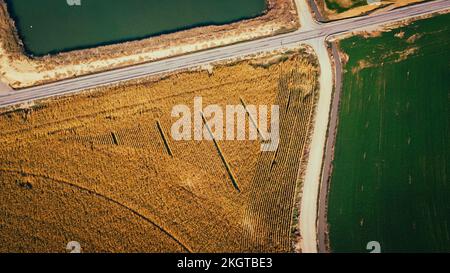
<box><xmin>6</xmin><ymin>0</ymin><xmax>267</xmax><ymax>56</ymax></box>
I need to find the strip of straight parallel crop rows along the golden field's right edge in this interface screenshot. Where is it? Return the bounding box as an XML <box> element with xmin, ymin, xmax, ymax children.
<box><xmin>244</xmin><ymin>65</ymin><xmax>317</xmax><ymax>252</ymax></box>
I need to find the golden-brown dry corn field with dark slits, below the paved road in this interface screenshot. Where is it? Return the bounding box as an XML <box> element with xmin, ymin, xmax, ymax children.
<box><xmin>0</xmin><ymin>49</ymin><xmax>319</xmax><ymax>252</ymax></box>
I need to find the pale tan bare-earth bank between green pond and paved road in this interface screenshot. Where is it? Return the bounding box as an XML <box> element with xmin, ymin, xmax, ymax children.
<box><xmin>0</xmin><ymin>0</ymin><xmax>300</xmax><ymax>89</ymax></box>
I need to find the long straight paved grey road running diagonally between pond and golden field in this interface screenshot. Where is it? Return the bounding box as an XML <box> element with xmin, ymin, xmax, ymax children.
<box><xmin>0</xmin><ymin>0</ymin><xmax>450</xmax><ymax>107</ymax></box>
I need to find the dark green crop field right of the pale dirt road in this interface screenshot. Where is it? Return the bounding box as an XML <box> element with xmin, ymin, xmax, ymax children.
<box><xmin>328</xmin><ymin>14</ymin><xmax>450</xmax><ymax>252</ymax></box>
